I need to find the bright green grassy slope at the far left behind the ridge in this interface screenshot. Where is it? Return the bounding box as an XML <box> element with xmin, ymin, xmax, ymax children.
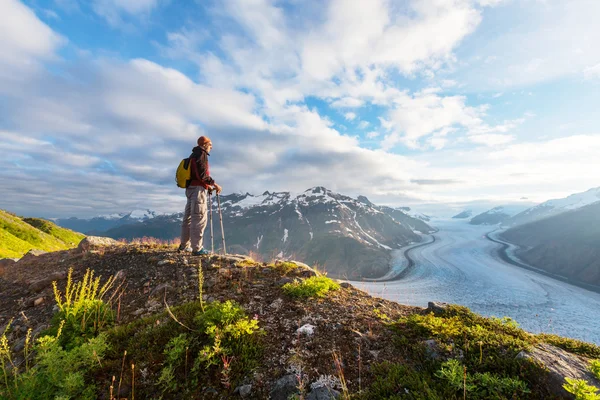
<box><xmin>0</xmin><ymin>210</ymin><xmax>84</xmax><ymax>258</ymax></box>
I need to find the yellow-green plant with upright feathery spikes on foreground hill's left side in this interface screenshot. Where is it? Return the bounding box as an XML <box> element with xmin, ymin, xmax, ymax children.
<box><xmin>50</xmin><ymin>268</ymin><xmax>114</xmax><ymax>347</ymax></box>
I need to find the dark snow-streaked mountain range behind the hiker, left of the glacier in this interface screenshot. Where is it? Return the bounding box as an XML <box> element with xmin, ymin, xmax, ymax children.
<box><xmin>57</xmin><ymin>187</ymin><xmax>433</xmax><ymax>279</ymax></box>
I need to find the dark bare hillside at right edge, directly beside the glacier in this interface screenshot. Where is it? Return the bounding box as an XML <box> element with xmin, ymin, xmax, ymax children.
<box><xmin>500</xmin><ymin>202</ymin><xmax>600</xmax><ymax>286</ymax></box>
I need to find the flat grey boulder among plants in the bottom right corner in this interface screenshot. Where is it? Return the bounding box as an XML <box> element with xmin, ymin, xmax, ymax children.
<box><xmin>517</xmin><ymin>343</ymin><xmax>600</xmax><ymax>397</ymax></box>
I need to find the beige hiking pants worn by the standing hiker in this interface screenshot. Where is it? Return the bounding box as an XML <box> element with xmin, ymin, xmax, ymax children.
<box><xmin>181</xmin><ymin>186</ymin><xmax>208</xmax><ymax>251</ymax></box>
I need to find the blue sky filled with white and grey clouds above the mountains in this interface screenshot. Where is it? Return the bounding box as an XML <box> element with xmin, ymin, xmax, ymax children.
<box><xmin>0</xmin><ymin>0</ymin><xmax>600</xmax><ymax>217</ymax></box>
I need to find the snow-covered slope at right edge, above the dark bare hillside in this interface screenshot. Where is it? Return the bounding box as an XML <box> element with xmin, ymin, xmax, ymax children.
<box><xmin>506</xmin><ymin>187</ymin><xmax>600</xmax><ymax>225</ymax></box>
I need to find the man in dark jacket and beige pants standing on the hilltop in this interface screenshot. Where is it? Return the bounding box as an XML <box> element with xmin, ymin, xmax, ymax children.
<box><xmin>179</xmin><ymin>136</ymin><xmax>222</xmax><ymax>256</ymax></box>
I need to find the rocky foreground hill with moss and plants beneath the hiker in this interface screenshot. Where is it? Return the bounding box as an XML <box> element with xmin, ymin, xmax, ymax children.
<box><xmin>0</xmin><ymin>245</ymin><xmax>600</xmax><ymax>400</ymax></box>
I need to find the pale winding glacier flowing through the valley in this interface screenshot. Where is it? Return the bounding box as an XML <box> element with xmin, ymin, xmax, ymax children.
<box><xmin>353</xmin><ymin>220</ymin><xmax>600</xmax><ymax>344</ymax></box>
